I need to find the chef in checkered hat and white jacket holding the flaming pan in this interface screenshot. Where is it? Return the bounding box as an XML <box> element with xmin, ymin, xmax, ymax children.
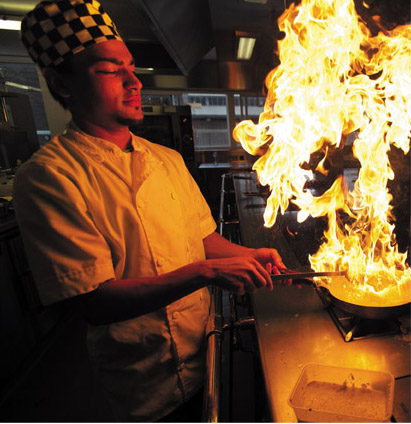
<box><xmin>15</xmin><ymin>0</ymin><xmax>283</xmax><ymax>421</ymax></box>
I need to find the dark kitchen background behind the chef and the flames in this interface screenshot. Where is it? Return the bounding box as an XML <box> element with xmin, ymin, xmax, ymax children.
<box><xmin>0</xmin><ymin>0</ymin><xmax>410</xmax><ymax>422</ymax></box>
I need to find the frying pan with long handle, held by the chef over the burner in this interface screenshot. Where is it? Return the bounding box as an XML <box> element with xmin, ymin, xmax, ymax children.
<box><xmin>271</xmin><ymin>272</ymin><xmax>411</xmax><ymax>320</ymax></box>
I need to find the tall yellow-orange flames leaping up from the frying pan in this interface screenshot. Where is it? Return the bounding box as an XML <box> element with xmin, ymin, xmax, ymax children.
<box><xmin>234</xmin><ymin>0</ymin><xmax>411</xmax><ymax>304</ymax></box>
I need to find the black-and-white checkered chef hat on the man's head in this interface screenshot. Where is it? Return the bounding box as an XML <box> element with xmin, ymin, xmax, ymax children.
<box><xmin>21</xmin><ymin>0</ymin><xmax>121</xmax><ymax>69</ymax></box>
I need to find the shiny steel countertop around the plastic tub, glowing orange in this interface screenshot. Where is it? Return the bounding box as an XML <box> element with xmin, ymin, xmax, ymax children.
<box><xmin>252</xmin><ymin>286</ymin><xmax>411</xmax><ymax>422</ymax></box>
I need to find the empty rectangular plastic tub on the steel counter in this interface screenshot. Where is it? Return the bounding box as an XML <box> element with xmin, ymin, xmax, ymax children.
<box><xmin>288</xmin><ymin>364</ymin><xmax>395</xmax><ymax>422</ymax></box>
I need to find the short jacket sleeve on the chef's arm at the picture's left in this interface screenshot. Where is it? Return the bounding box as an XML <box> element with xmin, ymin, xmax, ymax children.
<box><xmin>14</xmin><ymin>162</ymin><xmax>114</xmax><ymax>305</ymax></box>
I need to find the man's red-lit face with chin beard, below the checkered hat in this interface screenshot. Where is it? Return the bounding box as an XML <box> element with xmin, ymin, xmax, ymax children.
<box><xmin>67</xmin><ymin>40</ymin><xmax>143</xmax><ymax>130</ymax></box>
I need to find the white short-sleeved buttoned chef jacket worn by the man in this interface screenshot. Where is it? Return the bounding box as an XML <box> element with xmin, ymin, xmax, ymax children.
<box><xmin>14</xmin><ymin>123</ymin><xmax>216</xmax><ymax>421</ymax></box>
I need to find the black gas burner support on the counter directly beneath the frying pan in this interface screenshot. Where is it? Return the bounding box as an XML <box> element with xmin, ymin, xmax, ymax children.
<box><xmin>317</xmin><ymin>289</ymin><xmax>410</xmax><ymax>342</ymax></box>
